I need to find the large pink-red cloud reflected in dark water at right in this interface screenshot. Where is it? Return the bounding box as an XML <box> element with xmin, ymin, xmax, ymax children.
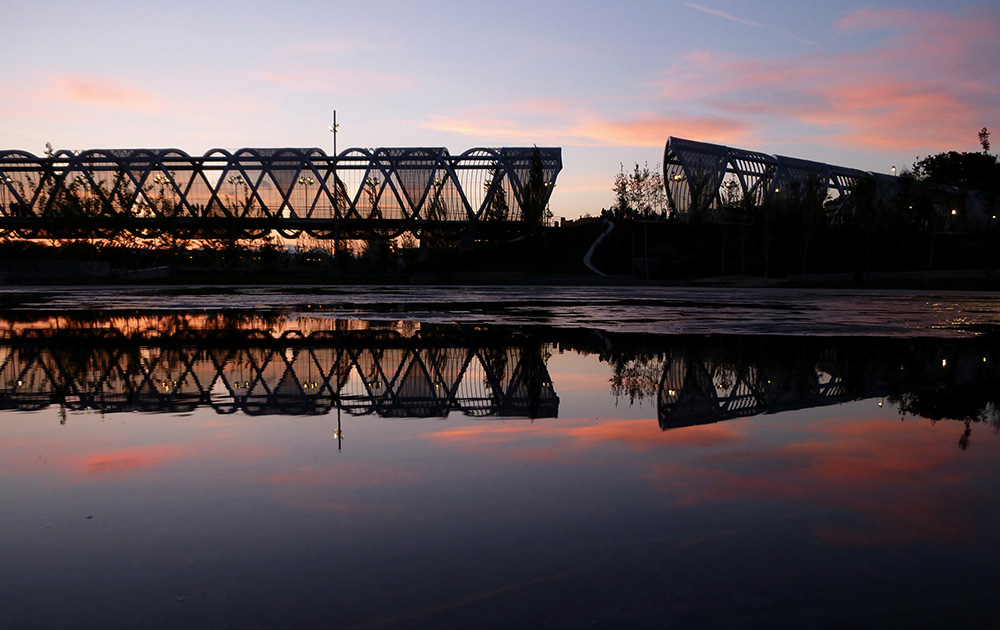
<box><xmin>645</xmin><ymin>419</ymin><xmax>978</xmax><ymax>545</ymax></box>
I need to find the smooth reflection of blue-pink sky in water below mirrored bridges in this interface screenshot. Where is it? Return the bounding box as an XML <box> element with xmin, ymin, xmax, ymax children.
<box><xmin>0</xmin><ymin>302</ymin><xmax>1000</xmax><ymax>628</ymax></box>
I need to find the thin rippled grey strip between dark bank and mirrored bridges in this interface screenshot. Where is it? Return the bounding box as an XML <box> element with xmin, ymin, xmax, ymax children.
<box><xmin>0</xmin><ymin>286</ymin><xmax>1000</xmax><ymax>336</ymax></box>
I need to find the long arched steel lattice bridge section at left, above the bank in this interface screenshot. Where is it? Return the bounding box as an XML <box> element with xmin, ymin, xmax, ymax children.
<box><xmin>0</xmin><ymin>147</ymin><xmax>562</xmax><ymax>239</ymax></box>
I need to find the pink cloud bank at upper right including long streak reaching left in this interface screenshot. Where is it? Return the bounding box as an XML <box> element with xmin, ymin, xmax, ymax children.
<box><xmin>423</xmin><ymin>9</ymin><xmax>1000</xmax><ymax>155</ymax></box>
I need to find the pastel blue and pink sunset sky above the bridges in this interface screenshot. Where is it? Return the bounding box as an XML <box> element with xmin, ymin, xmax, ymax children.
<box><xmin>0</xmin><ymin>0</ymin><xmax>1000</xmax><ymax>217</ymax></box>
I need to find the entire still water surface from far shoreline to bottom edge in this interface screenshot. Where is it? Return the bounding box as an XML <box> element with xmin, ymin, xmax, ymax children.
<box><xmin>0</xmin><ymin>287</ymin><xmax>1000</xmax><ymax>628</ymax></box>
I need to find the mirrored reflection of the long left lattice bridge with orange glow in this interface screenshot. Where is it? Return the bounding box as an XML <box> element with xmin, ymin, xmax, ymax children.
<box><xmin>0</xmin><ymin>315</ymin><xmax>559</xmax><ymax>418</ymax></box>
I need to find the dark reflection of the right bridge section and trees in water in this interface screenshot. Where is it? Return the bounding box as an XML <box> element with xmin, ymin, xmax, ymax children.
<box><xmin>655</xmin><ymin>337</ymin><xmax>1000</xmax><ymax>430</ymax></box>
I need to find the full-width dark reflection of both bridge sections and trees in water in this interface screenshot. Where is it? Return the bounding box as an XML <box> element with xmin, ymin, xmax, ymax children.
<box><xmin>0</xmin><ymin>313</ymin><xmax>1000</xmax><ymax>430</ymax></box>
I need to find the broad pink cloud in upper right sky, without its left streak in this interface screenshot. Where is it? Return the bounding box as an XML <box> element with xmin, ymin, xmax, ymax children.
<box><xmin>661</xmin><ymin>9</ymin><xmax>1000</xmax><ymax>152</ymax></box>
